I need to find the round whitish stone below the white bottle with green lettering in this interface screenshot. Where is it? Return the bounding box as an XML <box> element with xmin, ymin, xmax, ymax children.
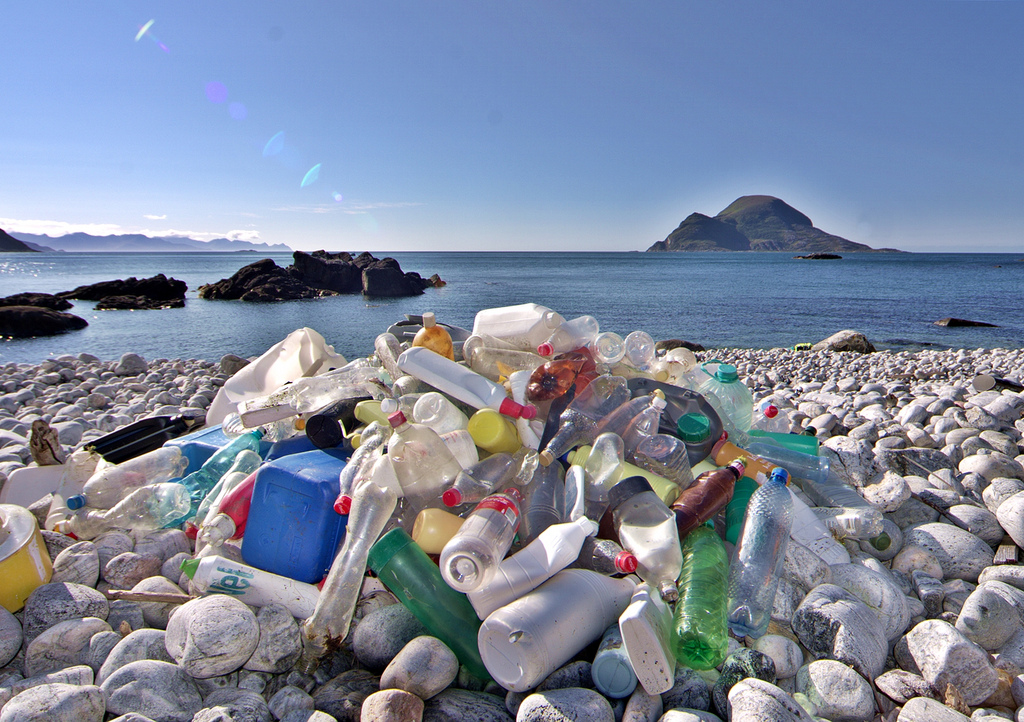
<box><xmin>161</xmin><ymin>589</ymin><xmax>259</xmax><ymax>679</ymax></box>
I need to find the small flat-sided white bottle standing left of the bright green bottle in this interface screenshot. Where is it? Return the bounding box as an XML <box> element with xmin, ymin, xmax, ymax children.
<box><xmin>618</xmin><ymin>584</ymin><xmax>676</xmax><ymax>694</ymax></box>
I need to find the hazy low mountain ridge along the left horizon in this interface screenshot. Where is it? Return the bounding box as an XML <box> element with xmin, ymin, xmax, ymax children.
<box><xmin>8</xmin><ymin>230</ymin><xmax>292</xmax><ymax>253</ymax></box>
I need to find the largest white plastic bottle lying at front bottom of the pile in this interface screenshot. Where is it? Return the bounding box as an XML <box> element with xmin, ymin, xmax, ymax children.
<box><xmin>477</xmin><ymin>569</ymin><xmax>636</xmax><ymax>692</ymax></box>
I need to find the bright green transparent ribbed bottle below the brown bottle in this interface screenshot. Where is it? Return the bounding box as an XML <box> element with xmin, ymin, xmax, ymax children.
<box><xmin>672</xmin><ymin>525</ymin><xmax>729</xmax><ymax>670</ymax></box>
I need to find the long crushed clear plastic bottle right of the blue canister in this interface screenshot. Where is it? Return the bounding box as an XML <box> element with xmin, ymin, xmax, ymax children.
<box><xmin>302</xmin><ymin>481</ymin><xmax>397</xmax><ymax>667</ymax></box>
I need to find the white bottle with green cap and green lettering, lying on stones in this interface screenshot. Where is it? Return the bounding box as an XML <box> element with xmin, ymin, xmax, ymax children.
<box><xmin>181</xmin><ymin>556</ymin><xmax>319</xmax><ymax>620</ymax></box>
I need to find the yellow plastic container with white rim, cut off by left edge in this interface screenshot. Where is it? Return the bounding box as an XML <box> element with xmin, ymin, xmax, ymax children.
<box><xmin>0</xmin><ymin>504</ymin><xmax>53</xmax><ymax>611</ymax></box>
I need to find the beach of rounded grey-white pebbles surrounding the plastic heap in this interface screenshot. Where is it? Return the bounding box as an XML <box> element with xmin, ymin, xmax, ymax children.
<box><xmin>0</xmin><ymin>340</ymin><xmax>1024</xmax><ymax>722</ymax></box>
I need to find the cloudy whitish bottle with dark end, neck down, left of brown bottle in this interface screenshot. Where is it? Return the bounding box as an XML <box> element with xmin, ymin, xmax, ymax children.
<box><xmin>608</xmin><ymin>476</ymin><xmax>683</xmax><ymax>602</ymax></box>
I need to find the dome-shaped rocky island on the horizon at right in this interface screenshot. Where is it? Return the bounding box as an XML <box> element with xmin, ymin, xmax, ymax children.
<box><xmin>647</xmin><ymin>196</ymin><xmax>898</xmax><ymax>253</ymax></box>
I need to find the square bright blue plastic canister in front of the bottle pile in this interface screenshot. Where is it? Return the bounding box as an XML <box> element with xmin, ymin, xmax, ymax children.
<box><xmin>242</xmin><ymin>449</ymin><xmax>348</xmax><ymax>584</ymax></box>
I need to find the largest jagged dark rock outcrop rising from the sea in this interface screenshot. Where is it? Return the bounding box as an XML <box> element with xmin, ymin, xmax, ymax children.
<box><xmin>199</xmin><ymin>251</ymin><xmax>444</xmax><ymax>301</ymax></box>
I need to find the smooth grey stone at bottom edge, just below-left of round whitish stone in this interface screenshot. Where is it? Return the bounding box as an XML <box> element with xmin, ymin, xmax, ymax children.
<box><xmin>100</xmin><ymin>660</ymin><xmax>203</xmax><ymax>722</ymax></box>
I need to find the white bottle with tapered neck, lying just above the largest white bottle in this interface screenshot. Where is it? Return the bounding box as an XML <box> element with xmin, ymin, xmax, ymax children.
<box><xmin>466</xmin><ymin>517</ymin><xmax>597</xmax><ymax>620</ymax></box>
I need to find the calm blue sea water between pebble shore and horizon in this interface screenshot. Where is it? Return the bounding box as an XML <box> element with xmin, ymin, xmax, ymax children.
<box><xmin>0</xmin><ymin>253</ymin><xmax>1024</xmax><ymax>364</ymax></box>
